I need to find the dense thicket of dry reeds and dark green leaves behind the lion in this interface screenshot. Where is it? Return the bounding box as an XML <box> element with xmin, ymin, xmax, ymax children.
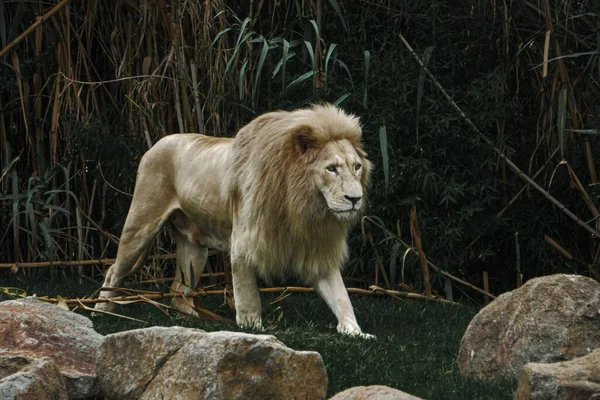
<box><xmin>0</xmin><ymin>0</ymin><xmax>600</xmax><ymax>300</ymax></box>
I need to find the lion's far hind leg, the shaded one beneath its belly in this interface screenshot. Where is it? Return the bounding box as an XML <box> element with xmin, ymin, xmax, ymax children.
<box><xmin>171</xmin><ymin>231</ymin><xmax>208</xmax><ymax>315</ymax></box>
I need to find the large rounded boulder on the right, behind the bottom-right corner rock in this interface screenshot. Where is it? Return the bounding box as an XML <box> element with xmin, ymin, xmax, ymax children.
<box><xmin>458</xmin><ymin>275</ymin><xmax>600</xmax><ymax>379</ymax></box>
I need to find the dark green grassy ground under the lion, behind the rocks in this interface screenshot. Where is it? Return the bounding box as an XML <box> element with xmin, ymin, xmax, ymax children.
<box><xmin>1</xmin><ymin>281</ymin><xmax>516</xmax><ymax>400</ymax></box>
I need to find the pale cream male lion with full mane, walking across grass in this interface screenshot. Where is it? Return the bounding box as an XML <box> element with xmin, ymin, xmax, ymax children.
<box><xmin>96</xmin><ymin>104</ymin><xmax>371</xmax><ymax>337</ymax></box>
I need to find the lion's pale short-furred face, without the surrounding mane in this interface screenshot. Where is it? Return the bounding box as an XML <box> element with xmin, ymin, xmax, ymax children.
<box><xmin>312</xmin><ymin>140</ymin><xmax>364</xmax><ymax>219</ymax></box>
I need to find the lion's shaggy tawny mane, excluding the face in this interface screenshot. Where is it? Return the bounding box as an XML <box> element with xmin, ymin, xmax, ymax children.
<box><xmin>224</xmin><ymin>105</ymin><xmax>370</xmax><ymax>284</ymax></box>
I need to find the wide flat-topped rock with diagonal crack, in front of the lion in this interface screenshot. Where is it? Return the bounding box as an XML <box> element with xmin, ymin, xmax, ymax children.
<box><xmin>97</xmin><ymin>327</ymin><xmax>327</xmax><ymax>400</ymax></box>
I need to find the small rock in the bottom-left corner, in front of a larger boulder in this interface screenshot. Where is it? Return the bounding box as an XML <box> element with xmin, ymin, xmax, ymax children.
<box><xmin>0</xmin><ymin>358</ymin><xmax>69</xmax><ymax>400</ymax></box>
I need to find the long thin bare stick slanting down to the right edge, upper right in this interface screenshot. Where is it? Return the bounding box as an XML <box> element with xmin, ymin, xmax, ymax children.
<box><xmin>398</xmin><ymin>34</ymin><xmax>600</xmax><ymax>239</ymax></box>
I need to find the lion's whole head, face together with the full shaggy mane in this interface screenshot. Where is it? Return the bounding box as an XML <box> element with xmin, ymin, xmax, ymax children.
<box><xmin>226</xmin><ymin>105</ymin><xmax>371</xmax><ymax>282</ymax></box>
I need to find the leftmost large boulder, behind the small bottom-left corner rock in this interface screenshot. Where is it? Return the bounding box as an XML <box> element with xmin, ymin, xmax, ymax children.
<box><xmin>0</xmin><ymin>297</ymin><xmax>103</xmax><ymax>399</ymax></box>
